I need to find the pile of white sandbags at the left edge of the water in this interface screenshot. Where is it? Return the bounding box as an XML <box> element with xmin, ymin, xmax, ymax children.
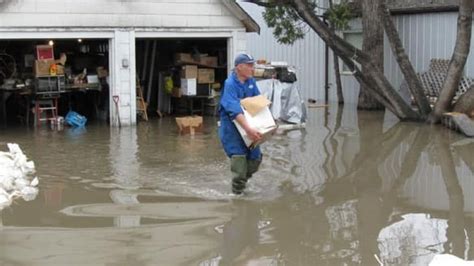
<box><xmin>0</xmin><ymin>143</ymin><xmax>38</xmax><ymax>211</ymax></box>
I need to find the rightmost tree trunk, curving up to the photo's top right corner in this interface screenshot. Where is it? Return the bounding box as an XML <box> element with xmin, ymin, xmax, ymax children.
<box><xmin>429</xmin><ymin>0</ymin><xmax>473</xmax><ymax>124</ymax></box>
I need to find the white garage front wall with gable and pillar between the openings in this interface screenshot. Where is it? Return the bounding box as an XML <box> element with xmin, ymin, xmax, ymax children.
<box><xmin>0</xmin><ymin>0</ymin><xmax>250</xmax><ymax>125</ymax></box>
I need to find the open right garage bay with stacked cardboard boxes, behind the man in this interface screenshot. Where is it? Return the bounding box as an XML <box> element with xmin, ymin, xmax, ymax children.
<box><xmin>136</xmin><ymin>38</ymin><xmax>228</xmax><ymax>117</ymax></box>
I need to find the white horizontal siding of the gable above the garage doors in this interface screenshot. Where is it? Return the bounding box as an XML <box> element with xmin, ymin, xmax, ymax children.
<box><xmin>0</xmin><ymin>0</ymin><xmax>242</xmax><ymax>28</ymax></box>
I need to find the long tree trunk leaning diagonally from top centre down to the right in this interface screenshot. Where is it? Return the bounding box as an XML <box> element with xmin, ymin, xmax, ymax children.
<box><xmin>291</xmin><ymin>0</ymin><xmax>420</xmax><ymax>120</ymax></box>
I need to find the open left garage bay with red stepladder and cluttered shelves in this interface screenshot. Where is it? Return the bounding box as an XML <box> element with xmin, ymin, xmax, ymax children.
<box><xmin>0</xmin><ymin>38</ymin><xmax>110</xmax><ymax>126</ymax></box>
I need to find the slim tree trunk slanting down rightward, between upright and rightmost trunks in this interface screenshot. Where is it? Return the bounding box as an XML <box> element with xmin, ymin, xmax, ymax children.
<box><xmin>381</xmin><ymin>2</ymin><xmax>431</xmax><ymax>118</ymax></box>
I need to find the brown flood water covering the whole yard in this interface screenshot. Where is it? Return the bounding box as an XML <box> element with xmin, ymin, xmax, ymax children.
<box><xmin>0</xmin><ymin>105</ymin><xmax>474</xmax><ymax>266</ymax></box>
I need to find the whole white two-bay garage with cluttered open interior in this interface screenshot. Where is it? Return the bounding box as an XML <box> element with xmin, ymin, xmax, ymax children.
<box><xmin>0</xmin><ymin>0</ymin><xmax>259</xmax><ymax>127</ymax></box>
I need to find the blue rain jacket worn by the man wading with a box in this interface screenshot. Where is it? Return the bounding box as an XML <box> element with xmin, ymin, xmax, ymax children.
<box><xmin>219</xmin><ymin>72</ymin><xmax>261</xmax><ymax>160</ymax></box>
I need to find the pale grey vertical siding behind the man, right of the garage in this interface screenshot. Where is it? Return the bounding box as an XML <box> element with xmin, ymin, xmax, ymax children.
<box><xmin>239</xmin><ymin>3</ymin><xmax>325</xmax><ymax>100</ymax></box>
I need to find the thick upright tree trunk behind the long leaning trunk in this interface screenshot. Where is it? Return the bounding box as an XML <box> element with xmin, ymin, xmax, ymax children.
<box><xmin>357</xmin><ymin>0</ymin><xmax>383</xmax><ymax>110</ymax></box>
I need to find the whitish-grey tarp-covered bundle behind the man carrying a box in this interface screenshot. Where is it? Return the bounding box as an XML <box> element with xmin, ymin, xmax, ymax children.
<box><xmin>257</xmin><ymin>79</ymin><xmax>306</xmax><ymax>124</ymax></box>
